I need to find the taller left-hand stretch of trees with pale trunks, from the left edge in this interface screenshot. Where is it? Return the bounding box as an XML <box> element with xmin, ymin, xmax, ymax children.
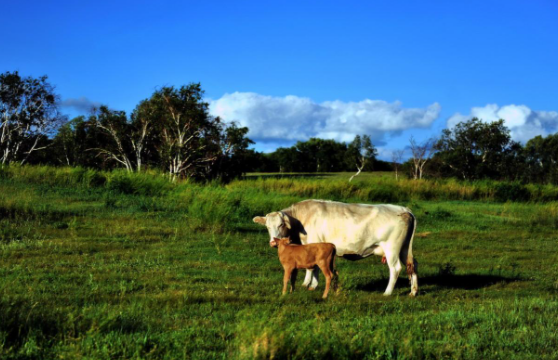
<box><xmin>0</xmin><ymin>72</ymin><xmax>253</xmax><ymax>180</ymax></box>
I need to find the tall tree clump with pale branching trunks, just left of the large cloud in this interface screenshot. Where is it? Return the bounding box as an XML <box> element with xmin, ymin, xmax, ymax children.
<box><xmin>85</xmin><ymin>84</ymin><xmax>253</xmax><ymax>180</ymax></box>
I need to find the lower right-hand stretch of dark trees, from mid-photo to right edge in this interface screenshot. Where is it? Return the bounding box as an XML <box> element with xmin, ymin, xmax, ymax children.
<box><xmin>241</xmin><ymin>118</ymin><xmax>558</xmax><ymax>184</ymax></box>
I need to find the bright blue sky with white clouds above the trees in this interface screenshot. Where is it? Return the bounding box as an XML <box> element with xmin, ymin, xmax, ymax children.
<box><xmin>0</xmin><ymin>0</ymin><xmax>558</xmax><ymax>158</ymax></box>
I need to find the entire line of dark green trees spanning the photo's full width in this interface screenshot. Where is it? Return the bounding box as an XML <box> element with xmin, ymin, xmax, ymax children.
<box><xmin>0</xmin><ymin>71</ymin><xmax>558</xmax><ymax>184</ymax></box>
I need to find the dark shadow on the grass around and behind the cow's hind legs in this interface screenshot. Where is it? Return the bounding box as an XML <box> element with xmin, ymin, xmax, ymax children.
<box><xmin>356</xmin><ymin>274</ymin><xmax>521</xmax><ymax>292</ymax></box>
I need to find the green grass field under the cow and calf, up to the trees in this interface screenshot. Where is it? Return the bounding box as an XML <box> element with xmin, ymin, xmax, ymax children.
<box><xmin>0</xmin><ymin>167</ymin><xmax>558</xmax><ymax>359</ymax></box>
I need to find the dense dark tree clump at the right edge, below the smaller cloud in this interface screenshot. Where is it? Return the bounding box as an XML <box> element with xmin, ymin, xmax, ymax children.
<box><xmin>426</xmin><ymin>118</ymin><xmax>558</xmax><ymax>184</ymax></box>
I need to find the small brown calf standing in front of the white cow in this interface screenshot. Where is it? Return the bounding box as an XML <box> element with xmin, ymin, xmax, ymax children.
<box><xmin>270</xmin><ymin>238</ymin><xmax>337</xmax><ymax>299</ymax></box>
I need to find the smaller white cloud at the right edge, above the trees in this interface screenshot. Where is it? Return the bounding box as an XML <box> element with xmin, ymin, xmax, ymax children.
<box><xmin>448</xmin><ymin>104</ymin><xmax>558</xmax><ymax>142</ymax></box>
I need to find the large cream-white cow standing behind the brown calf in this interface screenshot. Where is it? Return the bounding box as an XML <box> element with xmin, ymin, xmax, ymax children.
<box><xmin>254</xmin><ymin>200</ymin><xmax>418</xmax><ymax>296</ymax></box>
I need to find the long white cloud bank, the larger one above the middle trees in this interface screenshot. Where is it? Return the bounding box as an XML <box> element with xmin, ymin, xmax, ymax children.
<box><xmin>210</xmin><ymin>92</ymin><xmax>440</xmax><ymax>146</ymax></box>
